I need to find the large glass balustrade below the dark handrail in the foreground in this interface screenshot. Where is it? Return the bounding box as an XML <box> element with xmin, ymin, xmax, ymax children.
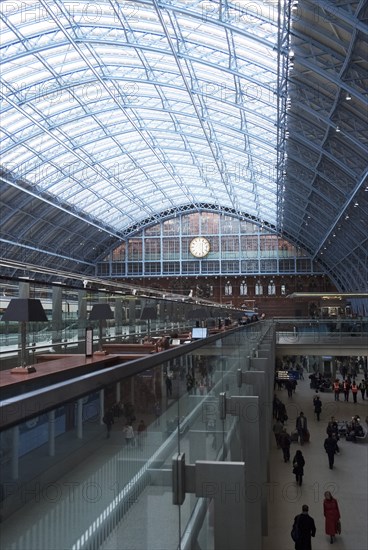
<box><xmin>1</xmin><ymin>323</ymin><xmax>268</xmax><ymax>550</ymax></box>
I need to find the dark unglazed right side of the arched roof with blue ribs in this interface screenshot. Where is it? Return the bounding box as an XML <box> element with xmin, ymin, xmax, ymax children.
<box><xmin>281</xmin><ymin>0</ymin><xmax>368</xmax><ymax>290</ymax></box>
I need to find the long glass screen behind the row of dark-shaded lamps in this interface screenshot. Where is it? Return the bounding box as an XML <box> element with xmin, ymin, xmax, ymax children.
<box><xmin>0</xmin><ymin>281</ymin><xmax>249</xmax><ymax>370</ymax></box>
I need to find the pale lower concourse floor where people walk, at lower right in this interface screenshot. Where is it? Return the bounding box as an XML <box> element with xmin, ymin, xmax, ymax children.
<box><xmin>262</xmin><ymin>374</ymin><xmax>368</xmax><ymax>550</ymax></box>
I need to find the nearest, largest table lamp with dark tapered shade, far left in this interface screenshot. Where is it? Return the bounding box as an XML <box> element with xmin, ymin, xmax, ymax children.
<box><xmin>2</xmin><ymin>298</ymin><xmax>48</xmax><ymax>374</ymax></box>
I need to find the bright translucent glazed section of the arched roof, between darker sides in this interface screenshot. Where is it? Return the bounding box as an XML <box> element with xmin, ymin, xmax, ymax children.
<box><xmin>0</xmin><ymin>0</ymin><xmax>277</xmax><ymax>230</ymax></box>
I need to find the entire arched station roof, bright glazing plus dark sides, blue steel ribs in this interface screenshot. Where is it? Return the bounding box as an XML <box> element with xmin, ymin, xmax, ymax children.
<box><xmin>0</xmin><ymin>0</ymin><xmax>368</xmax><ymax>290</ymax></box>
